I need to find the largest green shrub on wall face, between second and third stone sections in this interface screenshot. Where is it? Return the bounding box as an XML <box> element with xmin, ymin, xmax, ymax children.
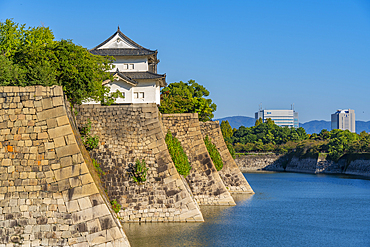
<box><xmin>166</xmin><ymin>130</ymin><xmax>191</xmax><ymax>177</ymax></box>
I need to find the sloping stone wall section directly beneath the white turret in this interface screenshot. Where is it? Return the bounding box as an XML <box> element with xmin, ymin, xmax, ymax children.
<box><xmin>76</xmin><ymin>104</ymin><xmax>203</xmax><ymax>222</ymax></box>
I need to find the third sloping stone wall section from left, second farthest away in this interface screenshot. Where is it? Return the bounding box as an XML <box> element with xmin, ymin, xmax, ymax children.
<box><xmin>162</xmin><ymin>113</ymin><xmax>235</xmax><ymax>205</ymax></box>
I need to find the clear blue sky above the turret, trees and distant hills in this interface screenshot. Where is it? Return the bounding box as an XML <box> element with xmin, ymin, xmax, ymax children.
<box><xmin>0</xmin><ymin>0</ymin><xmax>370</xmax><ymax>123</ymax></box>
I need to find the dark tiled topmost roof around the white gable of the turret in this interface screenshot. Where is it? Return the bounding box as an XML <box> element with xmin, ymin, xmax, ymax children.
<box><xmin>90</xmin><ymin>27</ymin><xmax>157</xmax><ymax>56</ymax></box>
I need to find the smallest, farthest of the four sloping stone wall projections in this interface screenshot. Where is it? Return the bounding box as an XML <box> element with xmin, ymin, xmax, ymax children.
<box><xmin>200</xmin><ymin>121</ymin><xmax>254</xmax><ymax>193</ymax></box>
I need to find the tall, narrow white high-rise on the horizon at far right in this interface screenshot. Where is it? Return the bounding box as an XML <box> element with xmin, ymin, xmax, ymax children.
<box><xmin>331</xmin><ymin>109</ymin><xmax>356</xmax><ymax>132</ymax></box>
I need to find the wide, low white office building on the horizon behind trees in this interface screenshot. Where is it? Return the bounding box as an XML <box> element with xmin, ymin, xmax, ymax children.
<box><xmin>255</xmin><ymin>110</ymin><xmax>299</xmax><ymax>128</ymax></box>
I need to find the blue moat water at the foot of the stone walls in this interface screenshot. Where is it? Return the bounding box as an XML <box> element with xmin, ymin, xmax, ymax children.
<box><xmin>123</xmin><ymin>173</ymin><xmax>370</xmax><ymax>247</ymax></box>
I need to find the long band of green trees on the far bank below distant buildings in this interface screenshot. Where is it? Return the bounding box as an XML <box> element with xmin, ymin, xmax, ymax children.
<box><xmin>231</xmin><ymin>121</ymin><xmax>370</xmax><ymax>162</ymax></box>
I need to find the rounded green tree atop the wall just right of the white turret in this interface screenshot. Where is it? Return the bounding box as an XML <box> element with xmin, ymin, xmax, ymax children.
<box><xmin>159</xmin><ymin>80</ymin><xmax>217</xmax><ymax>122</ymax></box>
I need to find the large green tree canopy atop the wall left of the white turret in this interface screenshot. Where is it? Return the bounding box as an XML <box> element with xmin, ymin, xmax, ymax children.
<box><xmin>0</xmin><ymin>19</ymin><xmax>122</xmax><ymax>104</ymax></box>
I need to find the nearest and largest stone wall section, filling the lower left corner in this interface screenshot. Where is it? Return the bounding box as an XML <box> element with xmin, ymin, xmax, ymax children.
<box><xmin>0</xmin><ymin>86</ymin><xmax>130</xmax><ymax>247</ymax></box>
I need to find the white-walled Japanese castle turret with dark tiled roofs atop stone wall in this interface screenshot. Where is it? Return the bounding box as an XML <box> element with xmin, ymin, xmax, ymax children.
<box><xmin>85</xmin><ymin>27</ymin><xmax>167</xmax><ymax>105</ymax></box>
